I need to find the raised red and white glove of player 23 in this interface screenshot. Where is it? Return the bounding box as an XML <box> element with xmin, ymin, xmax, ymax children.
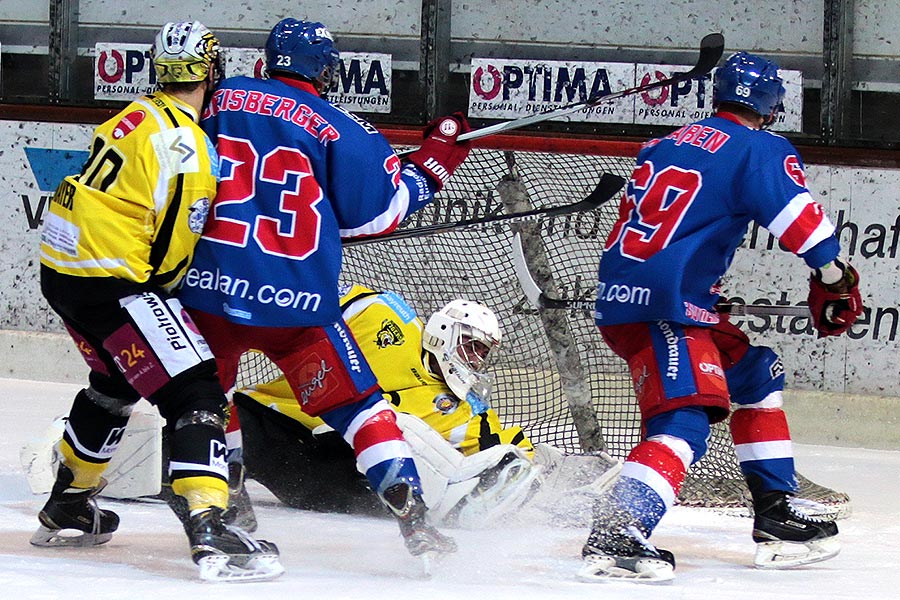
<box><xmin>406</xmin><ymin>112</ymin><xmax>472</xmax><ymax>191</ymax></box>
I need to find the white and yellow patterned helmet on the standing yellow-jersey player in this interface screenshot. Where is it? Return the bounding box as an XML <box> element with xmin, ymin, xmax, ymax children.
<box><xmin>151</xmin><ymin>21</ymin><xmax>225</xmax><ymax>86</ymax></box>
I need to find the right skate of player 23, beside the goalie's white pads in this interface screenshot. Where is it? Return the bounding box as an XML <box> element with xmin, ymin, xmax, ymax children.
<box><xmin>382</xmin><ymin>483</ymin><xmax>456</xmax><ymax>573</ymax></box>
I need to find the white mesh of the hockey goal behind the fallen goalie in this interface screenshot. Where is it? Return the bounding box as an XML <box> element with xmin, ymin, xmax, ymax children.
<box><xmin>238</xmin><ymin>142</ymin><xmax>849</xmax><ymax>512</ymax></box>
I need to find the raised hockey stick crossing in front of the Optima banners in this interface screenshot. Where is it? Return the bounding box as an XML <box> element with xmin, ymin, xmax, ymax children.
<box><xmin>397</xmin><ymin>33</ymin><xmax>725</xmax><ymax>157</ymax></box>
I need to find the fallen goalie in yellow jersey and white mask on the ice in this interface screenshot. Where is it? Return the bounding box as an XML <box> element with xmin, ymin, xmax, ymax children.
<box><xmin>228</xmin><ymin>285</ymin><xmax>617</xmax><ymax>527</ymax></box>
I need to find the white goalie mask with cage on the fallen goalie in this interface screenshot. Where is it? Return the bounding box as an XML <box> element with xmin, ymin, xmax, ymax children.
<box><xmin>422</xmin><ymin>300</ymin><xmax>500</xmax><ymax>414</ymax></box>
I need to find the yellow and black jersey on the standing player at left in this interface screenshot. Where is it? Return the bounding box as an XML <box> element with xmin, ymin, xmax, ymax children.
<box><xmin>41</xmin><ymin>92</ymin><xmax>218</xmax><ymax>290</ymax></box>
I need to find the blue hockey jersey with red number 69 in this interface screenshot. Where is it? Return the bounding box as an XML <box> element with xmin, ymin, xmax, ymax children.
<box><xmin>596</xmin><ymin>113</ymin><xmax>840</xmax><ymax>325</ymax></box>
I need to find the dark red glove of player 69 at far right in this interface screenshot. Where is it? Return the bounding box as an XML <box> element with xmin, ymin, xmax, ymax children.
<box><xmin>807</xmin><ymin>259</ymin><xmax>863</xmax><ymax>337</ymax></box>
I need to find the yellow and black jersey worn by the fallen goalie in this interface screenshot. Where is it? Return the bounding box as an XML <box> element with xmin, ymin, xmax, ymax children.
<box><xmin>242</xmin><ymin>285</ymin><xmax>533</xmax><ymax>455</ymax></box>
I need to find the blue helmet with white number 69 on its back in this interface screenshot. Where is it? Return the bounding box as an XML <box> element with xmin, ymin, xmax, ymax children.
<box><xmin>713</xmin><ymin>52</ymin><xmax>784</xmax><ymax>123</ymax></box>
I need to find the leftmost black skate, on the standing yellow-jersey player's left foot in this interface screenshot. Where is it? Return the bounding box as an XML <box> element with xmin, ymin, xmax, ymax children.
<box><xmin>31</xmin><ymin>463</ymin><xmax>119</xmax><ymax>546</ymax></box>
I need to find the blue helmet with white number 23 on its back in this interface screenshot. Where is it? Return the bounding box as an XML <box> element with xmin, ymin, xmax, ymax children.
<box><xmin>266</xmin><ymin>19</ymin><xmax>340</xmax><ymax>93</ymax></box>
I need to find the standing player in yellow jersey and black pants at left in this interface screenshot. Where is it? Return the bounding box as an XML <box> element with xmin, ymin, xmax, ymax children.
<box><xmin>31</xmin><ymin>21</ymin><xmax>283</xmax><ymax>580</ymax></box>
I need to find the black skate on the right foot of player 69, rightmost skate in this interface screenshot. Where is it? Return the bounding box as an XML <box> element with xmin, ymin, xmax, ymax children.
<box><xmin>753</xmin><ymin>492</ymin><xmax>841</xmax><ymax>569</ymax></box>
